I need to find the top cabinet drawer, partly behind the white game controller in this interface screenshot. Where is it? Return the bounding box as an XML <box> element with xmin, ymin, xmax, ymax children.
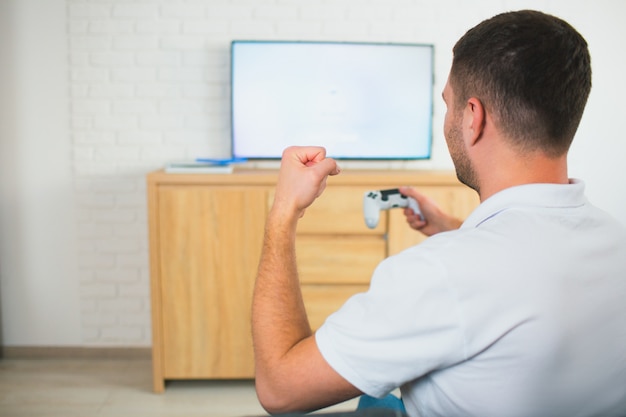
<box><xmin>298</xmin><ymin>186</ymin><xmax>387</xmax><ymax>235</ymax></box>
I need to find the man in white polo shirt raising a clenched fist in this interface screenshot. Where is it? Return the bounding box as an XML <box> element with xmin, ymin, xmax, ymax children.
<box><xmin>252</xmin><ymin>11</ymin><xmax>626</xmax><ymax>416</ymax></box>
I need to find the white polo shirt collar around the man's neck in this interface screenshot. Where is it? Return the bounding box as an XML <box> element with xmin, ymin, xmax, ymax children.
<box><xmin>461</xmin><ymin>179</ymin><xmax>587</xmax><ymax>229</ymax></box>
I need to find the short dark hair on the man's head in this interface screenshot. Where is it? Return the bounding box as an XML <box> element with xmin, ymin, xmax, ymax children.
<box><xmin>450</xmin><ymin>10</ymin><xmax>591</xmax><ymax>157</ymax></box>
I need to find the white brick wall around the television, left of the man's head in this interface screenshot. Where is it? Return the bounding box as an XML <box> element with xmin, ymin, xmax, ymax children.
<box><xmin>67</xmin><ymin>0</ymin><xmax>520</xmax><ymax>346</ymax></box>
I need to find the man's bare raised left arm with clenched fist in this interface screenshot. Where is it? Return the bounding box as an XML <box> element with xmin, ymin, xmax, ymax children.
<box><xmin>252</xmin><ymin>147</ymin><xmax>360</xmax><ymax>413</ymax></box>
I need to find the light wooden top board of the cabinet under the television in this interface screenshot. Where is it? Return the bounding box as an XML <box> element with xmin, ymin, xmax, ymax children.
<box><xmin>147</xmin><ymin>169</ymin><xmax>460</xmax><ymax>187</ymax></box>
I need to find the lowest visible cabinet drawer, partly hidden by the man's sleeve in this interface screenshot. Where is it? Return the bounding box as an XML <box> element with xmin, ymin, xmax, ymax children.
<box><xmin>302</xmin><ymin>285</ymin><xmax>369</xmax><ymax>330</ymax></box>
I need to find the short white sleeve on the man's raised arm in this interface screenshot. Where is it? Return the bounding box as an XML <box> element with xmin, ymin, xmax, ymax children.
<box><xmin>315</xmin><ymin>246</ymin><xmax>465</xmax><ymax>397</ymax></box>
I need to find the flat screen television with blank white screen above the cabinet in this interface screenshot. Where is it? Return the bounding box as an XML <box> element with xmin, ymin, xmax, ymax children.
<box><xmin>231</xmin><ymin>40</ymin><xmax>433</xmax><ymax>160</ymax></box>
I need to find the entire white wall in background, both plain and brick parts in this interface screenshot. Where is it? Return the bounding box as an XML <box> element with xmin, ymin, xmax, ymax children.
<box><xmin>0</xmin><ymin>0</ymin><xmax>626</xmax><ymax>346</ymax></box>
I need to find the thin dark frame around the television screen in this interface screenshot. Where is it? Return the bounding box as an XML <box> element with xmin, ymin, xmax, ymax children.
<box><xmin>230</xmin><ymin>39</ymin><xmax>435</xmax><ymax>161</ymax></box>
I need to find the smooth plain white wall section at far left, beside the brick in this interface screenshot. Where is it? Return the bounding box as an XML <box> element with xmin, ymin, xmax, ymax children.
<box><xmin>0</xmin><ymin>0</ymin><xmax>82</xmax><ymax>345</ymax></box>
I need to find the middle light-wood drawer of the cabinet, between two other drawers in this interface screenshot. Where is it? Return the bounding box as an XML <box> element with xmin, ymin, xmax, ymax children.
<box><xmin>296</xmin><ymin>235</ymin><xmax>386</xmax><ymax>284</ymax></box>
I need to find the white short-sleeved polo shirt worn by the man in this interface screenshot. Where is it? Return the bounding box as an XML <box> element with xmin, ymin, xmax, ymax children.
<box><xmin>316</xmin><ymin>181</ymin><xmax>626</xmax><ymax>417</ymax></box>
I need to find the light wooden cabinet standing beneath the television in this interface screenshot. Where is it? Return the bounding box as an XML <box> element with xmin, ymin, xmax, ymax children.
<box><xmin>147</xmin><ymin>170</ymin><xmax>478</xmax><ymax>392</ymax></box>
